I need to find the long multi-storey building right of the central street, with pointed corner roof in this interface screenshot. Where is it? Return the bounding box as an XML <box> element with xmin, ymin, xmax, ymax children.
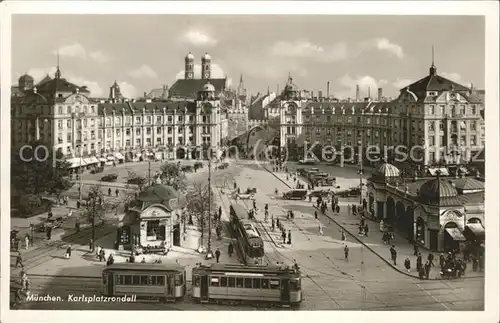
<box><xmin>274</xmin><ymin>64</ymin><xmax>484</xmax><ymax>166</ymax></box>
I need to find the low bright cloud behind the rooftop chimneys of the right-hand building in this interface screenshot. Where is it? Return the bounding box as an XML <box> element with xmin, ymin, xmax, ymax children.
<box><xmin>335</xmin><ymin>74</ymin><xmax>387</xmax><ymax>98</ymax></box>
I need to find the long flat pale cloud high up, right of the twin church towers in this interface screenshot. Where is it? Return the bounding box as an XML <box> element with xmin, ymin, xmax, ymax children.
<box><xmin>269</xmin><ymin>40</ymin><xmax>347</xmax><ymax>62</ymax></box>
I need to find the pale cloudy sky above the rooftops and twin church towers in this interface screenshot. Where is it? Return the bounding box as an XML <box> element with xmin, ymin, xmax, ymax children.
<box><xmin>12</xmin><ymin>15</ymin><xmax>485</xmax><ymax>97</ymax></box>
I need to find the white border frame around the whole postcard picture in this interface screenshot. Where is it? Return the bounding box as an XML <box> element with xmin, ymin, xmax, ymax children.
<box><xmin>0</xmin><ymin>1</ymin><xmax>500</xmax><ymax>323</ymax></box>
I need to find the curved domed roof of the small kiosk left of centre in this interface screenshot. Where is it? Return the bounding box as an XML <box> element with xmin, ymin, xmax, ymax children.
<box><xmin>136</xmin><ymin>184</ymin><xmax>186</xmax><ymax>211</ymax></box>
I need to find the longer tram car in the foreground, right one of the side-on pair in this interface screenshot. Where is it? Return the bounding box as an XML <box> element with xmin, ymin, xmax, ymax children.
<box><xmin>192</xmin><ymin>263</ymin><xmax>302</xmax><ymax>307</ymax></box>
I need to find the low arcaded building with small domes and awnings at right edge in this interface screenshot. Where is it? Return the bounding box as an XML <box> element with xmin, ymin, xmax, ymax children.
<box><xmin>367</xmin><ymin>163</ymin><xmax>485</xmax><ymax>251</ymax></box>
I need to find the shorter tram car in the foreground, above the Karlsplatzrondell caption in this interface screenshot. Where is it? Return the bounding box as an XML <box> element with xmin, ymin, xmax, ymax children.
<box><xmin>102</xmin><ymin>263</ymin><xmax>186</xmax><ymax>302</ymax></box>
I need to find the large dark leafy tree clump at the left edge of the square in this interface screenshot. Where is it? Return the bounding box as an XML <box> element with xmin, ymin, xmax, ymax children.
<box><xmin>11</xmin><ymin>141</ymin><xmax>73</xmax><ymax>197</ymax></box>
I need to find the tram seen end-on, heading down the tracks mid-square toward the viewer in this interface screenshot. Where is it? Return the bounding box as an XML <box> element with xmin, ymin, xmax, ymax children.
<box><xmin>229</xmin><ymin>204</ymin><xmax>264</xmax><ymax>264</ymax></box>
